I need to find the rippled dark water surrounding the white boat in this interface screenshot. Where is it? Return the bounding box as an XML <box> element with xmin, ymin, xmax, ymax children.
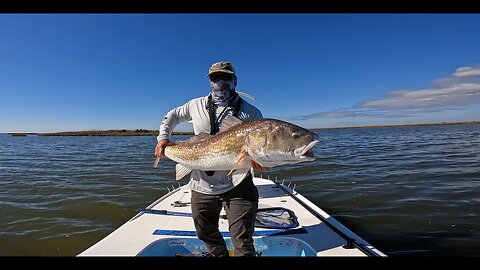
<box><xmin>0</xmin><ymin>125</ymin><xmax>480</xmax><ymax>256</ymax></box>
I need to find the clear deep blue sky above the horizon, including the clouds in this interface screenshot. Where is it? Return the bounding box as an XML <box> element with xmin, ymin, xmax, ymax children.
<box><xmin>0</xmin><ymin>14</ymin><xmax>480</xmax><ymax>132</ymax></box>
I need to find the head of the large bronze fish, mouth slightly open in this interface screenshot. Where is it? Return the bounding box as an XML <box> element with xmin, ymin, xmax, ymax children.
<box><xmin>247</xmin><ymin>119</ymin><xmax>319</xmax><ymax>167</ymax></box>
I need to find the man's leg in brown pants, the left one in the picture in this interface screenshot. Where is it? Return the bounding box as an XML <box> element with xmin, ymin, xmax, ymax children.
<box><xmin>191</xmin><ymin>191</ymin><xmax>228</xmax><ymax>257</ymax></box>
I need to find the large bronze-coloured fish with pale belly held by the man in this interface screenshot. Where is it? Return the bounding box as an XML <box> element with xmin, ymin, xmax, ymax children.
<box><xmin>154</xmin><ymin>116</ymin><xmax>319</xmax><ymax>183</ymax></box>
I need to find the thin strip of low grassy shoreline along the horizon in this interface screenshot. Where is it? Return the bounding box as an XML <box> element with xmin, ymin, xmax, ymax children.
<box><xmin>7</xmin><ymin>121</ymin><xmax>480</xmax><ymax>137</ymax></box>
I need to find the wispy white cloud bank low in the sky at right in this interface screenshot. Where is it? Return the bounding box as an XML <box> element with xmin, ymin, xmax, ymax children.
<box><xmin>294</xmin><ymin>66</ymin><xmax>480</xmax><ymax>120</ymax></box>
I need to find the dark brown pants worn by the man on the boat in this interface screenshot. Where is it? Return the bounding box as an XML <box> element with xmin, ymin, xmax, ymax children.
<box><xmin>191</xmin><ymin>174</ymin><xmax>258</xmax><ymax>256</ymax></box>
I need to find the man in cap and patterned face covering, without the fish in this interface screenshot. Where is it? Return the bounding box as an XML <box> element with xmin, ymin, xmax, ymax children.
<box><xmin>155</xmin><ymin>62</ymin><xmax>268</xmax><ymax>257</ymax></box>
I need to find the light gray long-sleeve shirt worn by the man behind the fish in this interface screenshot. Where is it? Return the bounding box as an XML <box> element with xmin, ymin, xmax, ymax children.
<box><xmin>157</xmin><ymin>96</ymin><xmax>263</xmax><ymax>195</ymax></box>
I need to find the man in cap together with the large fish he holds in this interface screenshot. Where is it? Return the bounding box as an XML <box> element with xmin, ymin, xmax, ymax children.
<box><xmin>155</xmin><ymin>62</ymin><xmax>318</xmax><ymax>257</ymax></box>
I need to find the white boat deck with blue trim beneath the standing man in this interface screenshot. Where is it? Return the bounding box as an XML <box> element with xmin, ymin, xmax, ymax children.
<box><xmin>77</xmin><ymin>171</ymin><xmax>386</xmax><ymax>257</ymax></box>
